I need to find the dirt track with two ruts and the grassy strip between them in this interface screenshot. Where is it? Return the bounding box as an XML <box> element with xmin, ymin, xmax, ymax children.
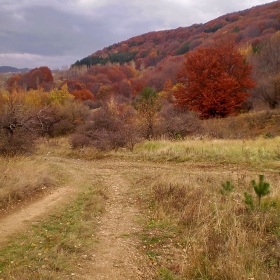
<box><xmin>0</xmin><ymin>157</ymin><xmax>153</xmax><ymax>280</ymax></box>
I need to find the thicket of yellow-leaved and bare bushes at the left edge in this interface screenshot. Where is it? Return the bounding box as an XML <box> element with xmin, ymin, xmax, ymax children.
<box><xmin>0</xmin><ymin>86</ymin><xmax>89</xmax><ymax>156</ymax></box>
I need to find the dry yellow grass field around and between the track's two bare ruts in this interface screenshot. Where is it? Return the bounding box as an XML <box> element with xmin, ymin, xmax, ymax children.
<box><xmin>0</xmin><ymin>137</ymin><xmax>280</xmax><ymax>280</ymax></box>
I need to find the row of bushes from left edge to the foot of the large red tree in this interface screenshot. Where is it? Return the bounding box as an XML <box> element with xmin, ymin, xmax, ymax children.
<box><xmin>0</xmin><ymin>82</ymin><xmax>199</xmax><ymax>156</ymax></box>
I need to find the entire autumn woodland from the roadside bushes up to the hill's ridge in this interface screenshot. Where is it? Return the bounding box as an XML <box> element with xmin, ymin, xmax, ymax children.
<box><xmin>0</xmin><ymin>2</ymin><xmax>280</xmax><ymax>154</ymax></box>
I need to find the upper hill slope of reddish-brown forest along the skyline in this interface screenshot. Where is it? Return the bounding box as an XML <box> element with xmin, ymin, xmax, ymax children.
<box><xmin>74</xmin><ymin>1</ymin><xmax>280</xmax><ymax>69</ymax></box>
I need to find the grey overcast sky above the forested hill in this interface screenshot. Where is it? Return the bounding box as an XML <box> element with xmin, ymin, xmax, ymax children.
<box><xmin>0</xmin><ymin>0</ymin><xmax>272</xmax><ymax>69</ymax></box>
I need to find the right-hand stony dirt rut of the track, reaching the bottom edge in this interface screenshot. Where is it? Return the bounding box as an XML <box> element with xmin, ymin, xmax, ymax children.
<box><xmin>77</xmin><ymin>171</ymin><xmax>153</xmax><ymax>280</ymax></box>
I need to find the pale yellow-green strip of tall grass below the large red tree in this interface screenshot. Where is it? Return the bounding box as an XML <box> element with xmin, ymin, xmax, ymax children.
<box><xmin>134</xmin><ymin>137</ymin><xmax>280</xmax><ymax>169</ymax></box>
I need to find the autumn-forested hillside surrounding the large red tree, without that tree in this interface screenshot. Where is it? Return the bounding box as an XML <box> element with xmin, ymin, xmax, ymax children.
<box><xmin>2</xmin><ymin>1</ymin><xmax>280</xmax><ymax>115</ymax></box>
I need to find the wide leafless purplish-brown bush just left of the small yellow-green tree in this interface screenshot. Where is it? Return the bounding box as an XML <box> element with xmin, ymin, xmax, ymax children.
<box><xmin>70</xmin><ymin>100</ymin><xmax>140</xmax><ymax>150</ymax></box>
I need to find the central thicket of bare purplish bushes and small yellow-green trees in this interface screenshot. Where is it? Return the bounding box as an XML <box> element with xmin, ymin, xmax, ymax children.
<box><xmin>70</xmin><ymin>88</ymin><xmax>199</xmax><ymax>150</ymax></box>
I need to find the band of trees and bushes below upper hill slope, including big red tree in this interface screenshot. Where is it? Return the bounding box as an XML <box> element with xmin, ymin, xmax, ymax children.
<box><xmin>0</xmin><ymin>32</ymin><xmax>280</xmax><ymax>158</ymax></box>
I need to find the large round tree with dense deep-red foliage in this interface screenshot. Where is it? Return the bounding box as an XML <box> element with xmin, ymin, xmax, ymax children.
<box><xmin>174</xmin><ymin>41</ymin><xmax>254</xmax><ymax>118</ymax></box>
